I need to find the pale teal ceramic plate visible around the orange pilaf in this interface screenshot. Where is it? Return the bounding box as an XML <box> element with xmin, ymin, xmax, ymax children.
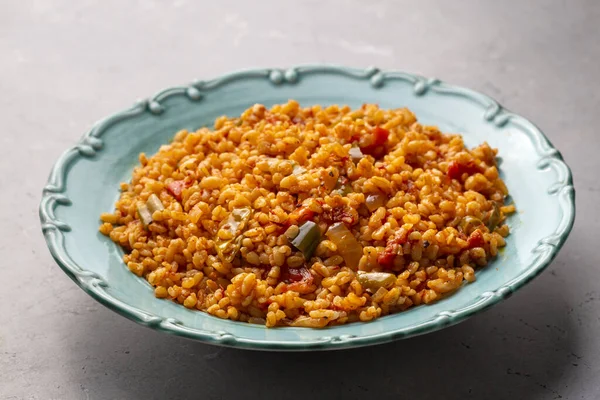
<box><xmin>40</xmin><ymin>66</ymin><xmax>575</xmax><ymax>350</ymax></box>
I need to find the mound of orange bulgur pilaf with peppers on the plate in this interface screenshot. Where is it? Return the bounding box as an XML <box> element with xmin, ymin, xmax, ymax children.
<box><xmin>100</xmin><ymin>101</ymin><xmax>515</xmax><ymax>328</ymax></box>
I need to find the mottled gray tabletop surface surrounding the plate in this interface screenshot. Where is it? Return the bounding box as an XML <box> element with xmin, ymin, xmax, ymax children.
<box><xmin>0</xmin><ymin>0</ymin><xmax>600</xmax><ymax>400</ymax></box>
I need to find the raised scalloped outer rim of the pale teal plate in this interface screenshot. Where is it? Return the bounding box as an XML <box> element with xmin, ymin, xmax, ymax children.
<box><xmin>39</xmin><ymin>64</ymin><xmax>576</xmax><ymax>350</ymax></box>
